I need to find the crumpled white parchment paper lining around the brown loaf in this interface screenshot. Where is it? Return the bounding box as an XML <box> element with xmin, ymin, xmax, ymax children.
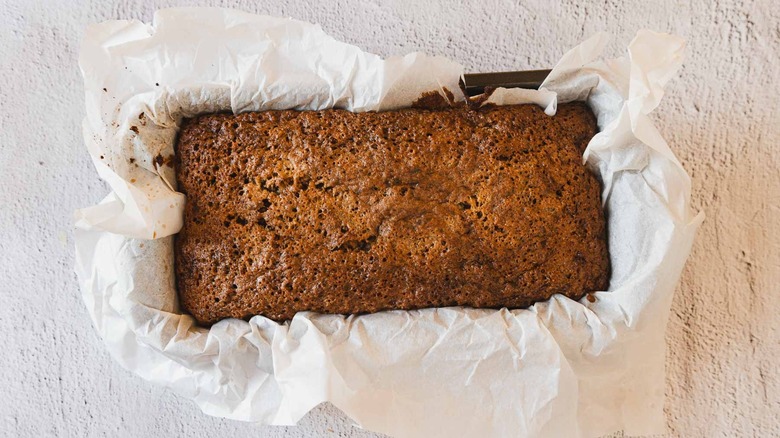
<box><xmin>76</xmin><ymin>9</ymin><xmax>703</xmax><ymax>437</ymax></box>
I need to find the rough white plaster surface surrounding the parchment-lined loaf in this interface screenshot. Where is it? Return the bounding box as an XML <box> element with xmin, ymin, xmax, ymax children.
<box><xmin>0</xmin><ymin>0</ymin><xmax>780</xmax><ymax>437</ymax></box>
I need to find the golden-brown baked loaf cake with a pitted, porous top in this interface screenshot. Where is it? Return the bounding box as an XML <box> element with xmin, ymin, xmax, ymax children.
<box><xmin>175</xmin><ymin>103</ymin><xmax>609</xmax><ymax>325</ymax></box>
